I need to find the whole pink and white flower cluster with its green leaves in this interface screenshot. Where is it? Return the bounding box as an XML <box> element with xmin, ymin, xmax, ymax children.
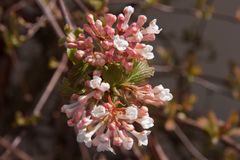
<box><xmin>62</xmin><ymin>6</ymin><xmax>172</xmax><ymax>153</ymax></box>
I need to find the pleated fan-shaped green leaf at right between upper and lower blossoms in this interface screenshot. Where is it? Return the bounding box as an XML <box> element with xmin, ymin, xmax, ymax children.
<box><xmin>125</xmin><ymin>61</ymin><xmax>154</xmax><ymax>84</ymax></box>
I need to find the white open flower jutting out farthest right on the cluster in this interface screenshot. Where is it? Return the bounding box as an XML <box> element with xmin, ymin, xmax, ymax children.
<box><xmin>153</xmin><ymin>85</ymin><xmax>173</xmax><ymax>101</ymax></box>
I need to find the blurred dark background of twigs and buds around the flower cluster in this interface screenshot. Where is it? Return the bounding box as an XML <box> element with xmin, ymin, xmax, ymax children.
<box><xmin>0</xmin><ymin>0</ymin><xmax>240</xmax><ymax>160</ymax></box>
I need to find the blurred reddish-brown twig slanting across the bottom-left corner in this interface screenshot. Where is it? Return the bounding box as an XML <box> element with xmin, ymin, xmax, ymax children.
<box><xmin>0</xmin><ymin>137</ymin><xmax>32</xmax><ymax>160</ymax></box>
